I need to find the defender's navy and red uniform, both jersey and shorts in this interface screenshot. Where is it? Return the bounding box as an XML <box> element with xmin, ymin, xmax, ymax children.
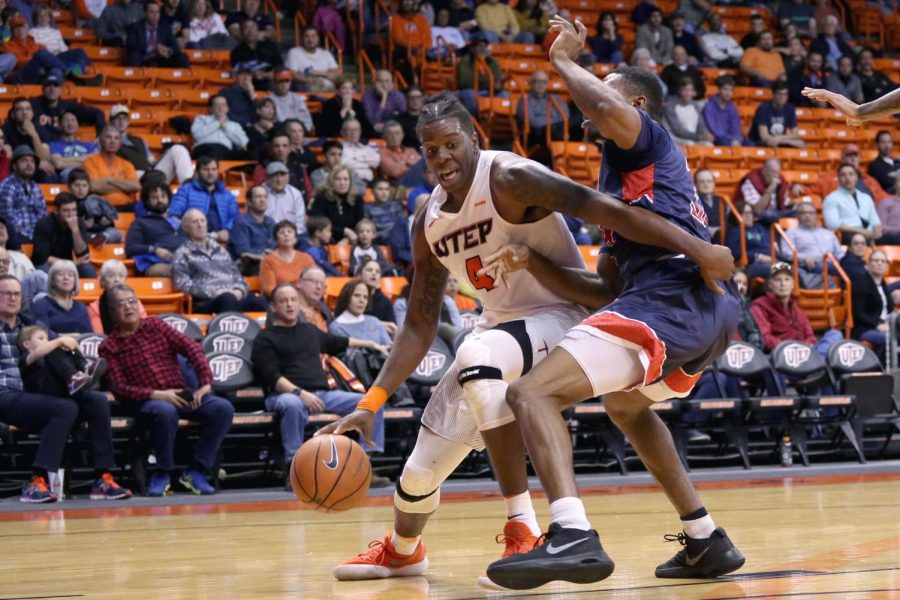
<box><xmin>582</xmin><ymin>112</ymin><xmax>740</xmax><ymax>399</ymax></box>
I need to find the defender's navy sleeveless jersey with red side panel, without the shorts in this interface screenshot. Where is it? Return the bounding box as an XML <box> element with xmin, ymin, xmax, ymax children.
<box><xmin>598</xmin><ymin>111</ymin><xmax>709</xmax><ymax>281</ymax></box>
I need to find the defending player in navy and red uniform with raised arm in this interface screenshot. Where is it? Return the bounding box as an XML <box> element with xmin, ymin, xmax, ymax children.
<box><xmin>486</xmin><ymin>17</ymin><xmax>744</xmax><ymax>589</ymax></box>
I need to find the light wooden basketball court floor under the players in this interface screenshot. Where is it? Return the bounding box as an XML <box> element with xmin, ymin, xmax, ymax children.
<box><xmin>0</xmin><ymin>474</ymin><xmax>900</xmax><ymax>600</ymax></box>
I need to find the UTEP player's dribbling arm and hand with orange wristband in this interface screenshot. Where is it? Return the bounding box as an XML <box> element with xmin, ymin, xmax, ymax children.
<box><xmin>316</xmin><ymin>210</ymin><xmax>448</xmax><ymax>442</ymax></box>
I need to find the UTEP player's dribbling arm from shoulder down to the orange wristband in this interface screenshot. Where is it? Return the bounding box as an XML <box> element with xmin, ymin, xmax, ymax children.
<box><xmin>374</xmin><ymin>211</ymin><xmax>448</xmax><ymax>394</ymax></box>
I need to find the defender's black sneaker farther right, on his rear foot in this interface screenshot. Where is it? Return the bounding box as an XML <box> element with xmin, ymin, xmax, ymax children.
<box><xmin>656</xmin><ymin>527</ymin><xmax>746</xmax><ymax>579</ymax></box>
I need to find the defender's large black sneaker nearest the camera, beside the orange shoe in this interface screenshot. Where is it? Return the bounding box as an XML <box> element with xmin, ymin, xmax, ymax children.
<box><xmin>487</xmin><ymin>523</ymin><xmax>615</xmax><ymax>590</ymax></box>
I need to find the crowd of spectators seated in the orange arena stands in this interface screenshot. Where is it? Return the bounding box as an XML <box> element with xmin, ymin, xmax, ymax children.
<box><xmin>0</xmin><ymin>0</ymin><xmax>900</xmax><ymax>502</ymax></box>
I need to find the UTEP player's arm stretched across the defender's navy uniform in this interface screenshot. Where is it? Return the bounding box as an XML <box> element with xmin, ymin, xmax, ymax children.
<box><xmin>491</xmin><ymin>159</ymin><xmax>734</xmax><ymax>294</ymax></box>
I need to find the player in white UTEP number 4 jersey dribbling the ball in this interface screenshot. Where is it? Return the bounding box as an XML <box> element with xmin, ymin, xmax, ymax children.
<box><xmin>318</xmin><ymin>94</ymin><xmax>733</xmax><ymax>585</ymax></box>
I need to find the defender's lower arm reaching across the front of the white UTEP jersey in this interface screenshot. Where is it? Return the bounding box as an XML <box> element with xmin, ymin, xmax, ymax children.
<box><xmin>478</xmin><ymin>244</ymin><xmax>619</xmax><ymax>310</ymax></box>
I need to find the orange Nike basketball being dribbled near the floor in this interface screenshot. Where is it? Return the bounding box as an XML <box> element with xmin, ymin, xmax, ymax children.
<box><xmin>291</xmin><ymin>435</ymin><xmax>372</xmax><ymax>512</ymax></box>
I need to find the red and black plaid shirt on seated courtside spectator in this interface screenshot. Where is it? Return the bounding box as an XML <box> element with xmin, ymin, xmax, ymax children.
<box><xmin>100</xmin><ymin>317</ymin><xmax>212</xmax><ymax>402</ymax></box>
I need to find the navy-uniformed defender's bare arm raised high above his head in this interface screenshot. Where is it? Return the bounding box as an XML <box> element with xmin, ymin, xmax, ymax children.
<box><xmin>550</xmin><ymin>16</ymin><xmax>641</xmax><ymax>149</ymax></box>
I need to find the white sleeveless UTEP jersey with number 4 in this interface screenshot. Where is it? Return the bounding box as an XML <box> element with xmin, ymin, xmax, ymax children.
<box><xmin>425</xmin><ymin>150</ymin><xmax>585</xmax><ymax>328</ymax></box>
